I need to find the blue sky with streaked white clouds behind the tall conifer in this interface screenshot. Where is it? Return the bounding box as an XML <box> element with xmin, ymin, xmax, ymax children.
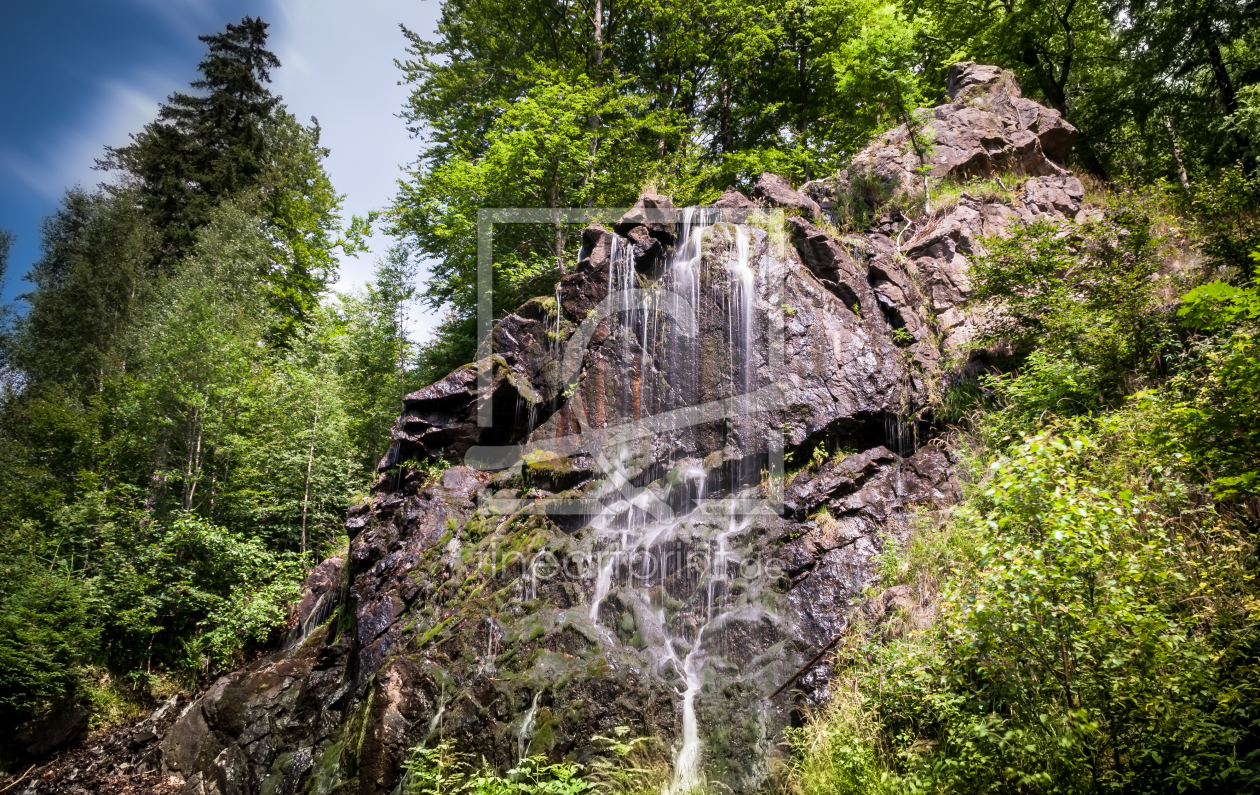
<box><xmin>0</xmin><ymin>0</ymin><xmax>440</xmax><ymax>334</ymax></box>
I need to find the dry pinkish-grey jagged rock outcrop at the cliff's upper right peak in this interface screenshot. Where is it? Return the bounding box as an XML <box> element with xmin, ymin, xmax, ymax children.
<box><xmin>801</xmin><ymin>62</ymin><xmax>1085</xmax><ymax>362</ymax></box>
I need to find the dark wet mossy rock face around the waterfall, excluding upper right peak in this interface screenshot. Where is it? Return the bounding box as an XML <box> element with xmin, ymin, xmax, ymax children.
<box><xmin>137</xmin><ymin>207</ymin><xmax>953</xmax><ymax>795</ymax></box>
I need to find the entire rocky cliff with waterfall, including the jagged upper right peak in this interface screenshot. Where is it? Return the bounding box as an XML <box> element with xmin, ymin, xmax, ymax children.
<box><xmin>18</xmin><ymin>64</ymin><xmax>1084</xmax><ymax>795</ymax></box>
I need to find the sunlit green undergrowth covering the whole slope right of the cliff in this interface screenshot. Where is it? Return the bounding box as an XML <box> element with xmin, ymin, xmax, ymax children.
<box><xmin>789</xmin><ymin>190</ymin><xmax>1260</xmax><ymax>795</ymax></box>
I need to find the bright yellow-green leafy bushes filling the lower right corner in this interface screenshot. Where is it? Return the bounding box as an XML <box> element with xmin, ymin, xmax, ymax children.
<box><xmin>796</xmin><ymin>425</ymin><xmax>1260</xmax><ymax>792</ymax></box>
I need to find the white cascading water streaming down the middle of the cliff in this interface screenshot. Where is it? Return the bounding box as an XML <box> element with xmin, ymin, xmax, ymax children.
<box><xmin>579</xmin><ymin>208</ymin><xmax>757</xmax><ymax>795</ymax></box>
